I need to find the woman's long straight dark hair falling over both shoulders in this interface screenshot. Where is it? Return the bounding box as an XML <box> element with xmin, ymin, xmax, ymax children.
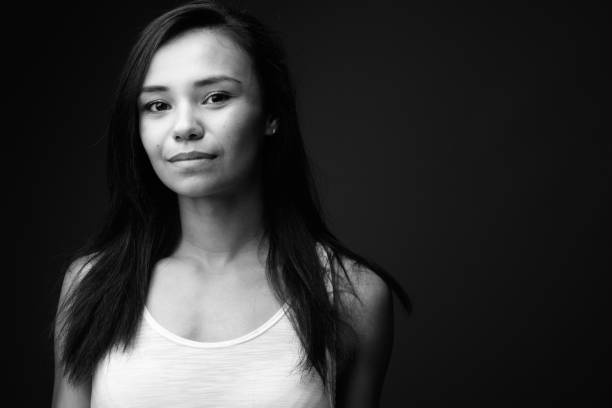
<box><xmin>54</xmin><ymin>1</ymin><xmax>410</xmax><ymax>400</ymax></box>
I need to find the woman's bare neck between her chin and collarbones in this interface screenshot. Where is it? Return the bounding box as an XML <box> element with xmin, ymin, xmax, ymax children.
<box><xmin>175</xmin><ymin>182</ymin><xmax>263</xmax><ymax>270</ymax></box>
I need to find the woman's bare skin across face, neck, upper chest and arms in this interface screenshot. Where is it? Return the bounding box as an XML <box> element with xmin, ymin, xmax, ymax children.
<box><xmin>54</xmin><ymin>29</ymin><xmax>393</xmax><ymax>408</ymax></box>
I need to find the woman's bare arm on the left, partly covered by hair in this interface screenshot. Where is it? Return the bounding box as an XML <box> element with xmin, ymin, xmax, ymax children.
<box><xmin>51</xmin><ymin>259</ymin><xmax>91</xmax><ymax>408</ymax></box>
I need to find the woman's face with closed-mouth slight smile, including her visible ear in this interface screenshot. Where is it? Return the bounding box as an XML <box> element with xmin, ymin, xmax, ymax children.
<box><xmin>139</xmin><ymin>29</ymin><xmax>274</xmax><ymax>198</ymax></box>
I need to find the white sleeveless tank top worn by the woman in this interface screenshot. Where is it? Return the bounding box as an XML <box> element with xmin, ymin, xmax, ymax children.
<box><xmin>91</xmin><ymin>250</ymin><xmax>334</xmax><ymax>408</ymax></box>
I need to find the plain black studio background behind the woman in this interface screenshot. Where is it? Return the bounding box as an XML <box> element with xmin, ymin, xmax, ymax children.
<box><xmin>14</xmin><ymin>0</ymin><xmax>612</xmax><ymax>407</ymax></box>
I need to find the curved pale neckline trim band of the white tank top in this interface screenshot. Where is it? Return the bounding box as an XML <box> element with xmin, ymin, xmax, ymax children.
<box><xmin>144</xmin><ymin>302</ymin><xmax>289</xmax><ymax>348</ymax></box>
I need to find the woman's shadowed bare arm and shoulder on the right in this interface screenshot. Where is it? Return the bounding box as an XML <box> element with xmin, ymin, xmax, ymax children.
<box><xmin>336</xmin><ymin>269</ymin><xmax>393</xmax><ymax>408</ymax></box>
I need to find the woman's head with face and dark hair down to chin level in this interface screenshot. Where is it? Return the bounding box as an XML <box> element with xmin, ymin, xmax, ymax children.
<box><xmin>108</xmin><ymin>1</ymin><xmax>311</xmax><ymax>226</ymax></box>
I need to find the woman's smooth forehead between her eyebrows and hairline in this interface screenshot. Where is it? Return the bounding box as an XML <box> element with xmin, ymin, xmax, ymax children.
<box><xmin>143</xmin><ymin>29</ymin><xmax>255</xmax><ymax>91</ymax></box>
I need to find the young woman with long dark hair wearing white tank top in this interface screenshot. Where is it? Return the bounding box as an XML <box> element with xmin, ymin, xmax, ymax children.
<box><xmin>53</xmin><ymin>1</ymin><xmax>409</xmax><ymax>408</ymax></box>
